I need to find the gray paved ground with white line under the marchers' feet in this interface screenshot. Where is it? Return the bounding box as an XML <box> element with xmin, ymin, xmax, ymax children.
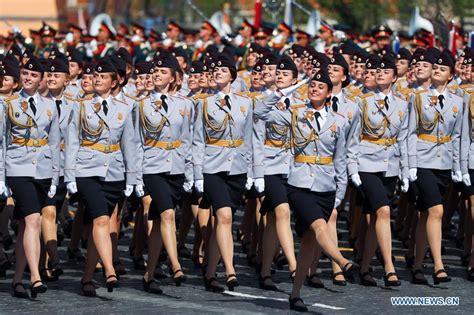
<box><xmin>0</xmin><ymin>207</ymin><xmax>474</xmax><ymax>314</ymax></box>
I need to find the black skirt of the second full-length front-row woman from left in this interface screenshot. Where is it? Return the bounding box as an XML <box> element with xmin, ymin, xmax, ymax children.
<box><xmin>76</xmin><ymin>177</ymin><xmax>125</xmax><ymax>224</ymax></box>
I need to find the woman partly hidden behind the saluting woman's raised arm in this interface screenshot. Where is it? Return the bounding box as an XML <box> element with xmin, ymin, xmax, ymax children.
<box><xmin>253</xmin><ymin>56</ymin><xmax>303</xmax><ymax>291</ymax></box>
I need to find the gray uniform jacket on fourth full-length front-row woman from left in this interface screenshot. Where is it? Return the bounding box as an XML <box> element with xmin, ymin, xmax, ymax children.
<box><xmin>192</xmin><ymin>92</ymin><xmax>253</xmax><ymax>180</ymax></box>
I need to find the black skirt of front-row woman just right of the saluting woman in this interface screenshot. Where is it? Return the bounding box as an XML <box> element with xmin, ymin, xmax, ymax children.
<box><xmin>359</xmin><ymin>172</ymin><xmax>398</xmax><ymax>213</ymax></box>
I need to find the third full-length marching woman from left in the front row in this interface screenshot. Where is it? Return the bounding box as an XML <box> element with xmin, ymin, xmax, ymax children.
<box><xmin>136</xmin><ymin>54</ymin><xmax>193</xmax><ymax>294</ymax></box>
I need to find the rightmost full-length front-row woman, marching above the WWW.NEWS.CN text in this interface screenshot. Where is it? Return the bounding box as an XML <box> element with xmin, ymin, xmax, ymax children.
<box><xmin>408</xmin><ymin>52</ymin><xmax>463</xmax><ymax>284</ymax></box>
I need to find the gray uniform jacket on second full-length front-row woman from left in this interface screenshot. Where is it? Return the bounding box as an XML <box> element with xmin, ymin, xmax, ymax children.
<box><xmin>64</xmin><ymin>95</ymin><xmax>137</xmax><ymax>185</ymax></box>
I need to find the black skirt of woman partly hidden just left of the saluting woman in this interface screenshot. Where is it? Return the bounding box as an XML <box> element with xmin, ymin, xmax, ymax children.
<box><xmin>260</xmin><ymin>174</ymin><xmax>288</xmax><ymax>214</ymax></box>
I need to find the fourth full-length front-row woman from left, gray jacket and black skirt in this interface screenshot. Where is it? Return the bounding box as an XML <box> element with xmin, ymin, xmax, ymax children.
<box><xmin>193</xmin><ymin>56</ymin><xmax>253</xmax><ymax>291</ymax></box>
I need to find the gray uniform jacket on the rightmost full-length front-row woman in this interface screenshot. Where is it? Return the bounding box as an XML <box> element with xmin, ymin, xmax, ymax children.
<box><xmin>408</xmin><ymin>88</ymin><xmax>462</xmax><ymax>172</ymax></box>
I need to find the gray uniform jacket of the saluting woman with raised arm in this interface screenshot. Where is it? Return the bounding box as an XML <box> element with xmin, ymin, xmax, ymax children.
<box><xmin>255</xmin><ymin>94</ymin><xmax>348</xmax><ymax>200</ymax></box>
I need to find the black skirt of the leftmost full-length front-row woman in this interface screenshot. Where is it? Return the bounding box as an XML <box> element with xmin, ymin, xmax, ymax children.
<box><xmin>7</xmin><ymin>176</ymin><xmax>51</xmax><ymax>220</ymax></box>
